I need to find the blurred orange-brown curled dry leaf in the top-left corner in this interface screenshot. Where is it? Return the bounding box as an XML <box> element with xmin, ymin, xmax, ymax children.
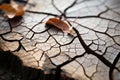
<box><xmin>0</xmin><ymin>1</ymin><xmax>25</xmax><ymax>18</ymax></box>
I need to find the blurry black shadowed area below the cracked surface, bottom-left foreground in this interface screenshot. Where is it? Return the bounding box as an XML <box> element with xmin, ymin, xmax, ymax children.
<box><xmin>0</xmin><ymin>50</ymin><xmax>74</xmax><ymax>80</ymax></box>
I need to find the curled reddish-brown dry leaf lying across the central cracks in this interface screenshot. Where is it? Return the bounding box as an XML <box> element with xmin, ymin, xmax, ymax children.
<box><xmin>46</xmin><ymin>18</ymin><xmax>74</xmax><ymax>35</ymax></box>
